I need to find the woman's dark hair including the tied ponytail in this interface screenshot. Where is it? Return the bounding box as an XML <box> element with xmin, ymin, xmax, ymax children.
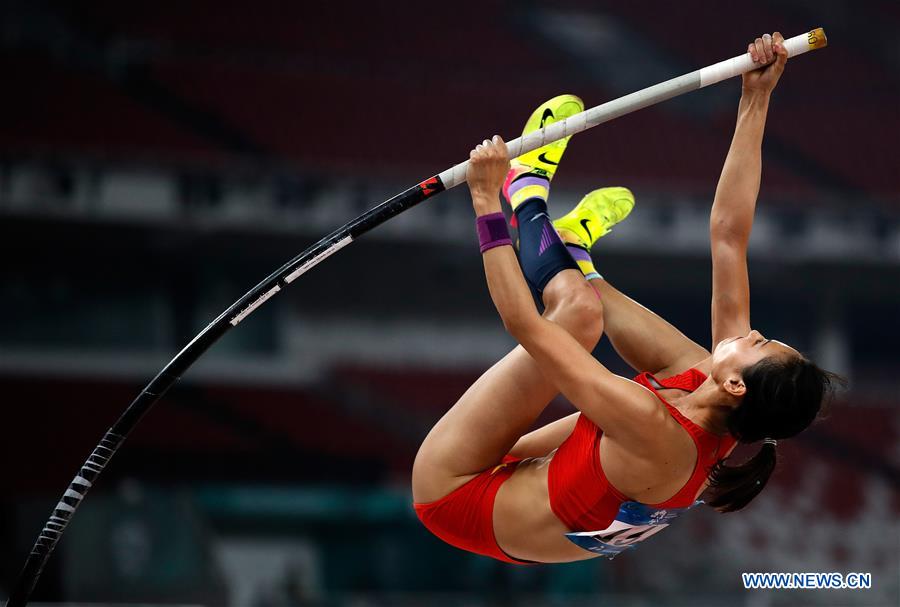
<box><xmin>705</xmin><ymin>356</ymin><xmax>846</xmax><ymax>512</ymax></box>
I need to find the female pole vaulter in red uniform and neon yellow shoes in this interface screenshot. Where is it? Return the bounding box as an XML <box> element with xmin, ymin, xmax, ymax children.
<box><xmin>412</xmin><ymin>32</ymin><xmax>837</xmax><ymax>564</ymax></box>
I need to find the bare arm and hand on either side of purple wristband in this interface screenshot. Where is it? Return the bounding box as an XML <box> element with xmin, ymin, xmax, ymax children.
<box><xmin>467</xmin><ymin>137</ymin><xmax>668</xmax><ymax>454</ymax></box>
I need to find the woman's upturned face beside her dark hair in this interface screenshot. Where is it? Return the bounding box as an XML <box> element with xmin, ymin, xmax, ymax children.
<box><xmin>712</xmin><ymin>330</ymin><xmax>800</xmax><ymax>397</ymax></box>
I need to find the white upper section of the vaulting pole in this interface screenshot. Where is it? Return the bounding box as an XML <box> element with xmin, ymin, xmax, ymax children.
<box><xmin>438</xmin><ymin>27</ymin><xmax>828</xmax><ymax>190</ymax></box>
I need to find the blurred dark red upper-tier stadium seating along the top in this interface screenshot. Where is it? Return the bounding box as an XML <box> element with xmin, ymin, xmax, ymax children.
<box><xmin>0</xmin><ymin>0</ymin><xmax>900</xmax><ymax>203</ymax></box>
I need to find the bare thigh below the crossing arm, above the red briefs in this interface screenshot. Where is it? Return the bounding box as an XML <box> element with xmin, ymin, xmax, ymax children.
<box><xmin>413</xmin><ymin>346</ymin><xmax>557</xmax><ymax>503</ymax></box>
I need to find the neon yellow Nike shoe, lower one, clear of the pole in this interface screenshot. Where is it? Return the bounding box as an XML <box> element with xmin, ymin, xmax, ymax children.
<box><xmin>553</xmin><ymin>187</ymin><xmax>634</xmax><ymax>250</ymax></box>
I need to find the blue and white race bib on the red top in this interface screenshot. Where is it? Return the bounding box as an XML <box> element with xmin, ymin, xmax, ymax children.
<box><xmin>566</xmin><ymin>500</ymin><xmax>703</xmax><ymax>558</ymax></box>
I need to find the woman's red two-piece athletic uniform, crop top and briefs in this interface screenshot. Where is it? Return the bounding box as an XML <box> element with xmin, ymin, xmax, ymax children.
<box><xmin>414</xmin><ymin>369</ymin><xmax>736</xmax><ymax>564</ymax></box>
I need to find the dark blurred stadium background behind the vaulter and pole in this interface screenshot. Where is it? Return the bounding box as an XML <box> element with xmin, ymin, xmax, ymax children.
<box><xmin>0</xmin><ymin>0</ymin><xmax>900</xmax><ymax>607</ymax></box>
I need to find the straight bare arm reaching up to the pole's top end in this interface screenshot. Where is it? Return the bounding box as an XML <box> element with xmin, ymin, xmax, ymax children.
<box><xmin>709</xmin><ymin>32</ymin><xmax>787</xmax><ymax>348</ymax></box>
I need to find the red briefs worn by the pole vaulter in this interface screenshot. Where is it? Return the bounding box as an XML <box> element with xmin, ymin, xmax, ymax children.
<box><xmin>413</xmin><ymin>456</ymin><xmax>530</xmax><ymax>565</ymax></box>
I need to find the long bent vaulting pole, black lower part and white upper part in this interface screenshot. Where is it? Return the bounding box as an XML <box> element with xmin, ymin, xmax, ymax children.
<box><xmin>6</xmin><ymin>28</ymin><xmax>826</xmax><ymax>607</ymax></box>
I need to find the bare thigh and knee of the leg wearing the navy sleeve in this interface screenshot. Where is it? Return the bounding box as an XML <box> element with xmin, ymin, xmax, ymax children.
<box><xmin>412</xmin><ymin>269</ymin><xmax>603</xmax><ymax>503</ymax></box>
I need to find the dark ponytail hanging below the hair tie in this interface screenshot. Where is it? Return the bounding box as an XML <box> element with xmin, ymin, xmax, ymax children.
<box><xmin>706</xmin><ymin>438</ymin><xmax>777</xmax><ymax>512</ymax></box>
